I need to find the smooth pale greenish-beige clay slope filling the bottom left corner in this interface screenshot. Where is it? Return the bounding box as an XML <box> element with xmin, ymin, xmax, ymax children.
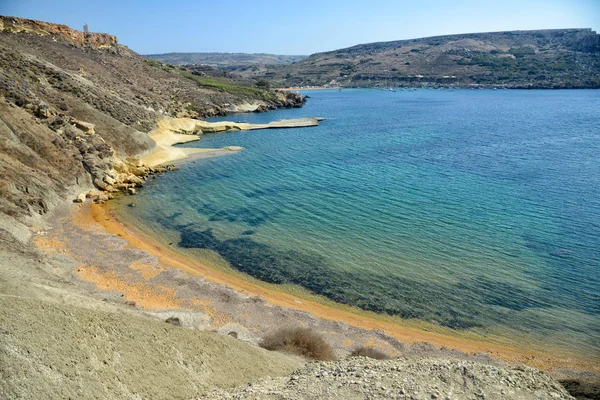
<box><xmin>0</xmin><ymin>295</ymin><xmax>303</xmax><ymax>399</ymax></box>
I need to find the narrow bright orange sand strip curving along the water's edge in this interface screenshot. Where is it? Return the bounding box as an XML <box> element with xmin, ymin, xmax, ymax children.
<box><xmin>83</xmin><ymin>204</ymin><xmax>600</xmax><ymax>374</ymax></box>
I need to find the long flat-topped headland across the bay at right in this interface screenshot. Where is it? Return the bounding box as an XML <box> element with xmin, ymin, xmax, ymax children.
<box><xmin>243</xmin><ymin>29</ymin><xmax>600</xmax><ymax>88</ymax></box>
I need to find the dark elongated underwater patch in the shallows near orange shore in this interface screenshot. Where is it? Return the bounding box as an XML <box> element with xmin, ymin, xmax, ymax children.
<box><xmin>171</xmin><ymin>226</ymin><xmax>556</xmax><ymax>329</ymax></box>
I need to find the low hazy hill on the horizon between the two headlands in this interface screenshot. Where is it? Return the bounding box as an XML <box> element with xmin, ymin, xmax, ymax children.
<box><xmin>146</xmin><ymin>53</ymin><xmax>307</xmax><ymax>68</ymax></box>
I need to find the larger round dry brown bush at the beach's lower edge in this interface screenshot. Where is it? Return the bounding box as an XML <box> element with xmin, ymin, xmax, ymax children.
<box><xmin>260</xmin><ymin>328</ymin><xmax>334</xmax><ymax>361</ymax></box>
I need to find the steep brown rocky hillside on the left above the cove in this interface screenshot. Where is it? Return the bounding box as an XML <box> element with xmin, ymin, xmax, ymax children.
<box><xmin>0</xmin><ymin>17</ymin><xmax>302</xmax><ymax>222</ymax></box>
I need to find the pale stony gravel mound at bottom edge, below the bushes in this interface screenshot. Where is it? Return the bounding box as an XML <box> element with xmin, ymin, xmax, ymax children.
<box><xmin>198</xmin><ymin>357</ymin><xmax>573</xmax><ymax>400</ymax></box>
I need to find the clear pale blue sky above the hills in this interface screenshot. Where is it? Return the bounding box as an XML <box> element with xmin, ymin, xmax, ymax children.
<box><xmin>0</xmin><ymin>0</ymin><xmax>600</xmax><ymax>54</ymax></box>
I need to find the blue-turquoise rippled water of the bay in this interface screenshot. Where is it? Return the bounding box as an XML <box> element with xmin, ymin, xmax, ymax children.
<box><xmin>117</xmin><ymin>90</ymin><xmax>600</xmax><ymax>356</ymax></box>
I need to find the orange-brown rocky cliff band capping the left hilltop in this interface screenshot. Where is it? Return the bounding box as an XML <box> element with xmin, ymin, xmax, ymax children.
<box><xmin>0</xmin><ymin>16</ymin><xmax>118</xmax><ymax>49</ymax></box>
